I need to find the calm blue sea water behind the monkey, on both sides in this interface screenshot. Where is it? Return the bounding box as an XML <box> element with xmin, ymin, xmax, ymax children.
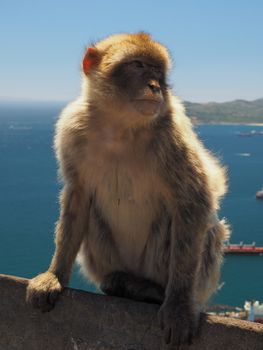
<box><xmin>0</xmin><ymin>106</ymin><xmax>263</xmax><ymax>305</ymax></box>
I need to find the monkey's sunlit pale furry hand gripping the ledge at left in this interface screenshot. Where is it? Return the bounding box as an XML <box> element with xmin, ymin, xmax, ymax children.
<box><xmin>26</xmin><ymin>271</ymin><xmax>63</xmax><ymax>312</ymax></box>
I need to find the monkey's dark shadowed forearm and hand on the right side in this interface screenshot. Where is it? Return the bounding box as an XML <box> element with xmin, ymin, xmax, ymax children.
<box><xmin>158</xmin><ymin>211</ymin><xmax>209</xmax><ymax>349</ymax></box>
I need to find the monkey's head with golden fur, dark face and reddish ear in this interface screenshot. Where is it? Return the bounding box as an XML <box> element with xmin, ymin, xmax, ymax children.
<box><xmin>83</xmin><ymin>33</ymin><xmax>173</xmax><ymax>125</ymax></box>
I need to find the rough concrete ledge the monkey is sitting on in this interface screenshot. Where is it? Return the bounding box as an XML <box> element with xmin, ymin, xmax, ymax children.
<box><xmin>0</xmin><ymin>275</ymin><xmax>263</xmax><ymax>350</ymax></box>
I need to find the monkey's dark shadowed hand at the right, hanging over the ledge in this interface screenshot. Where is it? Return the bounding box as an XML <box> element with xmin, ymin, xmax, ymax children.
<box><xmin>158</xmin><ymin>301</ymin><xmax>199</xmax><ymax>349</ymax></box>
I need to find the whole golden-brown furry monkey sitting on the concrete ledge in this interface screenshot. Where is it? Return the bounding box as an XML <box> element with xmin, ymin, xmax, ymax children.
<box><xmin>27</xmin><ymin>32</ymin><xmax>229</xmax><ymax>348</ymax></box>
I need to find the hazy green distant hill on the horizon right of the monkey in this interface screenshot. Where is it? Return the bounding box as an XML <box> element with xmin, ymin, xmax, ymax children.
<box><xmin>184</xmin><ymin>98</ymin><xmax>263</xmax><ymax>124</ymax></box>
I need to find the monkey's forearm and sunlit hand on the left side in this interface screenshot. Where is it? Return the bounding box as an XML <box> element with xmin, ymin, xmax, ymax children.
<box><xmin>27</xmin><ymin>186</ymin><xmax>89</xmax><ymax>311</ymax></box>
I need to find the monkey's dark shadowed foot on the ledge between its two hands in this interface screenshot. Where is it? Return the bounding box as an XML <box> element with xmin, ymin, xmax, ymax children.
<box><xmin>100</xmin><ymin>271</ymin><xmax>164</xmax><ymax>304</ymax></box>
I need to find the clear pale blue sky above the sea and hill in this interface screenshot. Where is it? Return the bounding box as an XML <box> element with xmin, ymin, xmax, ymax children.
<box><xmin>0</xmin><ymin>0</ymin><xmax>263</xmax><ymax>102</ymax></box>
